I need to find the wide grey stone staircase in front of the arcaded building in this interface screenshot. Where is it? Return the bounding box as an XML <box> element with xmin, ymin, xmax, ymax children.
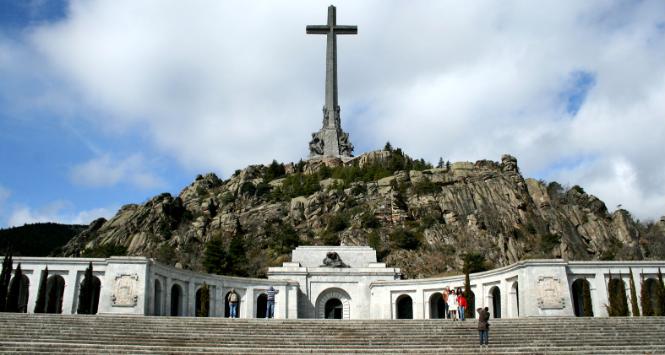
<box><xmin>0</xmin><ymin>313</ymin><xmax>665</xmax><ymax>355</ymax></box>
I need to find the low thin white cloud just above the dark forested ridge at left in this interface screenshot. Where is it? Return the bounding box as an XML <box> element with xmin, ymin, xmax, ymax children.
<box><xmin>7</xmin><ymin>201</ymin><xmax>117</xmax><ymax>227</ymax></box>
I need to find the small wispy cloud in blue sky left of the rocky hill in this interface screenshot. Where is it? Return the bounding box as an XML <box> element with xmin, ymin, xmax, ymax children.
<box><xmin>71</xmin><ymin>154</ymin><xmax>165</xmax><ymax>189</ymax></box>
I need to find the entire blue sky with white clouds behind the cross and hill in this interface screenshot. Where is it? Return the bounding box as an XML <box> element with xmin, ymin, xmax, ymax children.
<box><xmin>0</xmin><ymin>0</ymin><xmax>665</xmax><ymax>227</ymax></box>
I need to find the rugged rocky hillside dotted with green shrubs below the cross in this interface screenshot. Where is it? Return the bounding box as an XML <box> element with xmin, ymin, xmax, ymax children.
<box><xmin>63</xmin><ymin>149</ymin><xmax>665</xmax><ymax>278</ymax></box>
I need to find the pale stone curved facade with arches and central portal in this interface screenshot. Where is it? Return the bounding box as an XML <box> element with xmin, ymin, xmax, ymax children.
<box><xmin>7</xmin><ymin>247</ymin><xmax>665</xmax><ymax>319</ymax></box>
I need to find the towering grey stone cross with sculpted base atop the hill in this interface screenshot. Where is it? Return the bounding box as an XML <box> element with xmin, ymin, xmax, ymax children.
<box><xmin>306</xmin><ymin>5</ymin><xmax>358</xmax><ymax>157</ymax></box>
